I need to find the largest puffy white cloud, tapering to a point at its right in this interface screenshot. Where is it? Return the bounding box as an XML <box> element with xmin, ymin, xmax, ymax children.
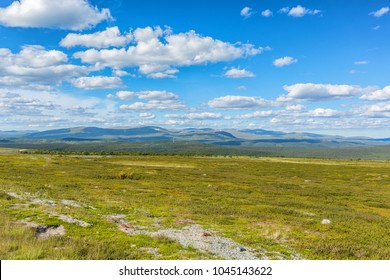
<box><xmin>74</xmin><ymin>27</ymin><xmax>264</xmax><ymax>78</ymax></box>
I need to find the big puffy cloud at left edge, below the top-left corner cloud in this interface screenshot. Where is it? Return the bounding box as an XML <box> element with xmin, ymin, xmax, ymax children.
<box><xmin>0</xmin><ymin>45</ymin><xmax>92</xmax><ymax>86</ymax></box>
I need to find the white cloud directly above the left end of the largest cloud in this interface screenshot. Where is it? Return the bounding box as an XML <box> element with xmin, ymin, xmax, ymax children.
<box><xmin>60</xmin><ymin>26</ymin><xmax>132</xmax><ymax>49</ymax></box>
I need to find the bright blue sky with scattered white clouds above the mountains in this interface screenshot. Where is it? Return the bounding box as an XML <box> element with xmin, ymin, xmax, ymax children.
<box><xmin>0</xmin><ymin>0</ymin><xmax>390</xmax><ymax>137</ymax></box>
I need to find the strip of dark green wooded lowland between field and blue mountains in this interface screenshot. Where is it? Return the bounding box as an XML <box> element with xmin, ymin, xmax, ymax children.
<box><xmin>0</xmin><ymin>139</ymin><xmax>390</xmax><ymax>160</ymax></box>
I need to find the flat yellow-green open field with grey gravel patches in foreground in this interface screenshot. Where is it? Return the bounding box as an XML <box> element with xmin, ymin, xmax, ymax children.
<box><xmin>0</xmin><ymin>150</ymin><xmax>390</xmax><ymax>259</ymax></box>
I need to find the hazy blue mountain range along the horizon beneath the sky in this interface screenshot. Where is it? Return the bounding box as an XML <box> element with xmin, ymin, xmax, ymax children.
<box><xmin>0</xmin><ymin>126</ymin><xmax>390</xmax><ymax>148</ymax></box>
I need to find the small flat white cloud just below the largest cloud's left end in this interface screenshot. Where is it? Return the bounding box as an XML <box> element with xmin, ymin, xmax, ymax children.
<box><xmin>72</xmin><ymin>76</ymin><xmax>123</xmax><ymax>90</ymax></box>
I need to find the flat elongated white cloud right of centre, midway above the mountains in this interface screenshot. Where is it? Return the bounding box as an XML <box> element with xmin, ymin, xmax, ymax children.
<box><xmin>207</xmin><ymin>95</ymin><xmax>269</xmax><ymax>110</ymax></box>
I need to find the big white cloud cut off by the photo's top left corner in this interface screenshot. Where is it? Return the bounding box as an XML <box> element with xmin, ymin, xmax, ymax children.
<box><xmin>0</xmin><ymin>0</ymin><xmax>112</xmax><ymax>30</ymax></box>
